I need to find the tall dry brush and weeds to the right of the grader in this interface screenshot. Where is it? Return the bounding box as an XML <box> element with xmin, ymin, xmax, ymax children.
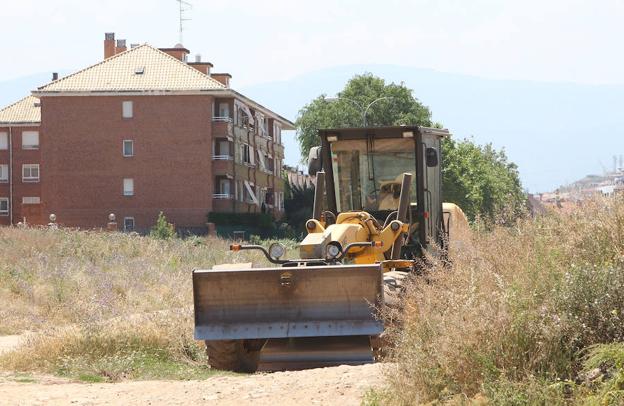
<box><xmin>386</xmin><ymin>198</ymin><xmax>624</xmax><ymax>405</ymax></box>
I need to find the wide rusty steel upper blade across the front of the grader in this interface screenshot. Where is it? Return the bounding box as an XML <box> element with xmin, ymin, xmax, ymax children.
<box><xmin>193</xmin><ymin>264</ymin><xmax>383</xmax><ymax>340</ymax></box>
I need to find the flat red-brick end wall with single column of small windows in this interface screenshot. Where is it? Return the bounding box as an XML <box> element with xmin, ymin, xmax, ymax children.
<box><xmin>41</xmin><ymin>95</ymin><xmax>213</xmax><ymax>230</ymax></box>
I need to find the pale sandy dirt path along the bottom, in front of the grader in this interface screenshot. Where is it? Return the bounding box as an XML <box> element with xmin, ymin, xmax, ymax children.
<box><xmin>0</xmin><ymin>364</ymin><xmax>382</xmax><ymax>406</ymax></box>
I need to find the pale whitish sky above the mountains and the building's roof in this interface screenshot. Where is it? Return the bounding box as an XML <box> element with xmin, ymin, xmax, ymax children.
<box><xmin>0</xmin><ymin>0</ymin><xmax>624</xmax><ymax>87</ymax></box>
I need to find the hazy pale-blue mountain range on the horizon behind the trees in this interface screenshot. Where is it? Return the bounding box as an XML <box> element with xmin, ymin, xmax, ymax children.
<box><xmin>0</xmin><ymin>65</ymin><xmax>624</xmax><ymax>192</ymax></box>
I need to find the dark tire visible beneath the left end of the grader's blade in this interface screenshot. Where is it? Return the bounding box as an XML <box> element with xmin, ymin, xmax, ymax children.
<box><xmin>206</xmin><ymin>340</ymin><xmax>262</xmax><ymax>373</ymax></box>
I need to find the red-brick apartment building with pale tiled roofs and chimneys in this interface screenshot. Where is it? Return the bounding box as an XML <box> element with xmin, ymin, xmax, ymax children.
<box><xmin>0</xmin><ymin>34</ymin><xmax>294</xmax><ymax>231</ymax></box>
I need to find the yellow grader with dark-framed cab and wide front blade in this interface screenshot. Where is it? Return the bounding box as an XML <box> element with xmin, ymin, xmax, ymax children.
<box><xmin>193</xmin><ymin>126</ymin><xmax>466</xmax><ymax>372</ymax></box>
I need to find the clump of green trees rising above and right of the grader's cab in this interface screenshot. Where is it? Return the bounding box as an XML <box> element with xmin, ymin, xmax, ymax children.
<box><xmin>296</xmin><ymin>74</ymin><xmax>526</xmax><ymax>220</ymax></box>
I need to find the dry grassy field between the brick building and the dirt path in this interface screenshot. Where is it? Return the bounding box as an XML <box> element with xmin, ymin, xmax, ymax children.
<box><xmin>0</xmin><ymin>228</ymin><xmax>280</xmax><ymax>381</ymax></box>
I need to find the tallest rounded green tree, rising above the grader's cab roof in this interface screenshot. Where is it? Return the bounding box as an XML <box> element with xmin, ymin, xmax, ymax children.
<box><xmin>295</xmin><ymin>73</ymin><xmax>432</xmax><ymax>159</ymax></box>
